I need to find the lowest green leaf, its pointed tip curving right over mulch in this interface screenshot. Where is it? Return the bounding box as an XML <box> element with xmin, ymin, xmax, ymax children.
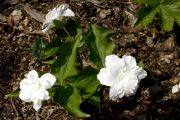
<box><xmin>54</xmin><ymin>85</ymin><xmax>90</xmax><ymax>117</ymax></box>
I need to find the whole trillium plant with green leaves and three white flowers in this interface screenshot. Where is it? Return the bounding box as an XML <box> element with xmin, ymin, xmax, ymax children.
<box><xmin>9</xmin><ymin>4</ymin><xmax>147</xmax><ymax>117</ymax></box>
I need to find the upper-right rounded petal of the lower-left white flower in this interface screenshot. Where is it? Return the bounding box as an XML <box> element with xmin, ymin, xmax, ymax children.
<box><xmin>39</xmin><ymin>73</ymin><xmax>56</xmax><ymax>89</ymax></box>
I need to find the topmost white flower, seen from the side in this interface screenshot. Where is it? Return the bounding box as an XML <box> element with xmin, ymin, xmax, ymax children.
<box><xmin>42</xmin><ymin>4</ymin><xmax>74</xmax><ymax>32</ymax></box>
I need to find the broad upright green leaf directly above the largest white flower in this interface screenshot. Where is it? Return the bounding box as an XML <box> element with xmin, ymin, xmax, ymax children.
<box><xmin>83</xmin><ymin>24</ymin><xmax>115</xmax><ymax>68</ymax></box>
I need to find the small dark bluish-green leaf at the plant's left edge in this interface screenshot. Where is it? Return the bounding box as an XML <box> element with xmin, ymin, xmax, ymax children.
<box><xmin>31</xmin><ymin>38</ymin><xmax>47</xmax><ymax>60</ymax></box>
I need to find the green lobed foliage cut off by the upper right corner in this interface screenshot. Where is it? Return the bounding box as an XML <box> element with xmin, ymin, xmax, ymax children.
<box><xmin>134</xmin><ymin>0</ymin><xmax>180</xmax><ymax>31</ymax></box>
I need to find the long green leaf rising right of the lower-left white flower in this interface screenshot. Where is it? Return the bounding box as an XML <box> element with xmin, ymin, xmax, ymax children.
<box><xmin>52</xmin><ymin>43</ymin><xmax>78</xmax><ymax>85</ymax></box>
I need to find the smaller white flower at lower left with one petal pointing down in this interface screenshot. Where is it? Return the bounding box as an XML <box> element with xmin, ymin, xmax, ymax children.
<box><xmin>19</xmin><ymin>70</ymin><xmax>56</xmax><ymax>111</ymax></box>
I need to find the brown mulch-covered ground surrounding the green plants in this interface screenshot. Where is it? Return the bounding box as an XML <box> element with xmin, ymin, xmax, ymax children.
<box><xmin>0</xmin><ymin>0</ymin><xmax>180</xmax><ymax>120</ymax></box>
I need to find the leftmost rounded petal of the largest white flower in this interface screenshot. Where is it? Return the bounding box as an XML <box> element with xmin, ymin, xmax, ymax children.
<box><xmin>97</xmin><ymin>68</ymin><xmax>115</xmax><ymax>86</ymax></box>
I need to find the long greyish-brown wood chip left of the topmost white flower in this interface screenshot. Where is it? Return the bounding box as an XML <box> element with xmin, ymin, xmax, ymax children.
<box><xmin>24</xmin><ymin>3</ymin><xmax>44</xmax><ymax>22</ymax></box>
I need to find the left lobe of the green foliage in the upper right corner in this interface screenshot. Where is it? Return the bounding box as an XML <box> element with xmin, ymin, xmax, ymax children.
<box><xmin>135</xmin><ymin>7</ymin><xmax>157</xmax><ymax>27</ymax></box>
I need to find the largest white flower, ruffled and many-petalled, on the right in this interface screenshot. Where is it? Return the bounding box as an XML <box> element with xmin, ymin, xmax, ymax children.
<box><xmin>97</xmin><ymin>55</ymin><xmax>147</xmax><ymax>100</ymax></box>
